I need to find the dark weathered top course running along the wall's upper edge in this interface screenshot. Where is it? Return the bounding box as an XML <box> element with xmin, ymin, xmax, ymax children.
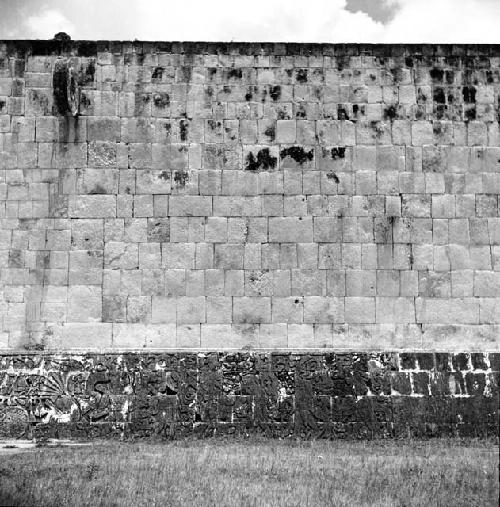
<box><xmin>0</xmin><ymin>39</ymin><xmax>500</xmax><ymax>58</ymax></box>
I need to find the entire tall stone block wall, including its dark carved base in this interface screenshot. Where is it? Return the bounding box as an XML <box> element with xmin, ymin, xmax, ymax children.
<box><xmin>0</xmin><ymin>40</ymin><xmax>500</xmax><ymax>437</ymax></box>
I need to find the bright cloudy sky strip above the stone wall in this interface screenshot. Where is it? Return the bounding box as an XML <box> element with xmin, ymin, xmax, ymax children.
<box><xmin>0</xmin><ymin>0</ymin><xmax>500</xmax><ymax>43</ymax></box>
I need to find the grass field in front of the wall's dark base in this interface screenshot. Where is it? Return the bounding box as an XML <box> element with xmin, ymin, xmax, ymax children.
<box><xmin>0</xmin><ymin>440</ymin><xmax>499</xmax><ymax>507</ymax></box>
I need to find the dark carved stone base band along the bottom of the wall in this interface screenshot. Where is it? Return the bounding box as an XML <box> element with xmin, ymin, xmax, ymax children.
<box><xmin>0</xmin><ymin>352</ymin><xmax>500</xmax><ymax>439</ymax></box>
